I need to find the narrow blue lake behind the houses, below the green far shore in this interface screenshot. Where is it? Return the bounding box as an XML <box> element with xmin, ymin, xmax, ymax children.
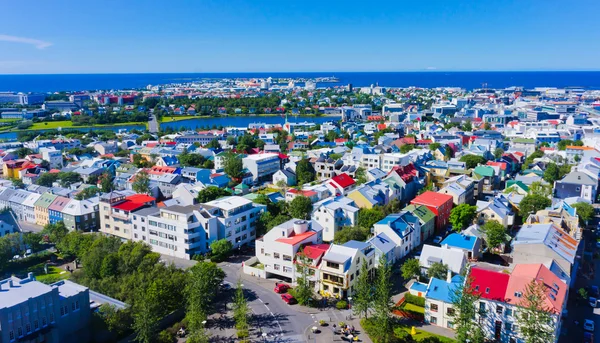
<box><xmin>0</xmin><ymin>116</ymin><xmax>341</xmax><ymax>141</ymax></box>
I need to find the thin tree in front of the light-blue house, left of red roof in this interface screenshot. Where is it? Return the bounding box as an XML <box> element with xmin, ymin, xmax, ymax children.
<box><xmin>450</xmin><ymin>277</ymin><xmax>484</xmax><ymax>343</ymax></box>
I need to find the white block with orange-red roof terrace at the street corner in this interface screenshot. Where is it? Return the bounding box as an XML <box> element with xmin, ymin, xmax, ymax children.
<box><xmin>256</xmin><ymin>219</ymin><xmax>323</xmax><ymax>282</ymax></box>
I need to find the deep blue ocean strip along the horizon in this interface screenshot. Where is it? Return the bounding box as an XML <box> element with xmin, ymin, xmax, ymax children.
<box><xmin>0</xmin><ymin>71</ymin><xmax>600</xmax><ymax>92</ymax></box>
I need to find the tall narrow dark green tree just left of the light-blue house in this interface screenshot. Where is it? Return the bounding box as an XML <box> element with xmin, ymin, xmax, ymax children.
<box><xmin>370</xmin><ymin>255</ymin><xmax>394</xmax><ymax>343</ymax></box>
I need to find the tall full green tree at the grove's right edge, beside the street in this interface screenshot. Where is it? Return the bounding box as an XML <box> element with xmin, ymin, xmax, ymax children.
<box><xmin>184</xmin><ymin>261</ymin><xmax>225</xmax><ymax>338</ymax></box>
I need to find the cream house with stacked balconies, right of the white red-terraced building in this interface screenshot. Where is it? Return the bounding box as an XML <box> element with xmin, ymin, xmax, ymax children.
<box><xmin>319</xmin><ymin>241</ymin><xmax>375</xmax><ymax>299</ymax></box>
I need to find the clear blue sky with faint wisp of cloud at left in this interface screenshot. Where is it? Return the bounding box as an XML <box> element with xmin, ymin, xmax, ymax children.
<box><xmin>0</xmin><ymin>0</ymin><xmax>600</xmax><ymax>74</ymax></box>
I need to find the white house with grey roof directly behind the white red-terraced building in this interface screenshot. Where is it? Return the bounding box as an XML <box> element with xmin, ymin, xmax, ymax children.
<box><xmin>311</xmin><ymin>196</ymin><xmax>359</xmax><ymax>242</ymax></box>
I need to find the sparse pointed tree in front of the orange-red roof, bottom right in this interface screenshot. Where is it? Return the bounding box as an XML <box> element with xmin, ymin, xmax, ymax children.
<box><xmin>517</xmin><ymin>279</ymin><xmax>554</xmax><ymax>343</ymax></box>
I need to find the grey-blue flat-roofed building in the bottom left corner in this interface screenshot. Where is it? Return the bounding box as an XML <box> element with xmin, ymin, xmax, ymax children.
<box><xmin>0</xmin><ymin>273</ymin><xmax>91</xmax><ymax>343</ymax></box>
